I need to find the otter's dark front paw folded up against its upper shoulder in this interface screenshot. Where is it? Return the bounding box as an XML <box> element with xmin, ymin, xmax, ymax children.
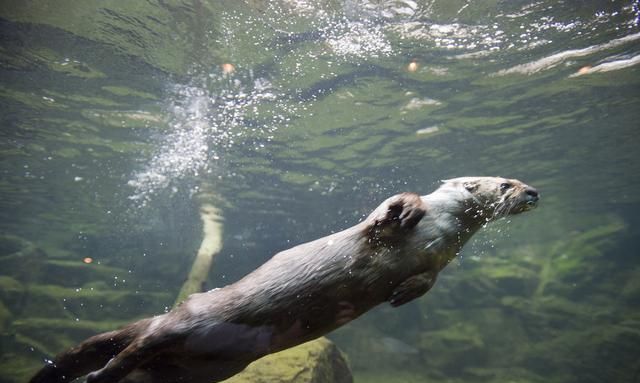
<box><xmin>368</xmin><ymin>193</ymin><xmax>427</xmax><ymax>240</ymax></box>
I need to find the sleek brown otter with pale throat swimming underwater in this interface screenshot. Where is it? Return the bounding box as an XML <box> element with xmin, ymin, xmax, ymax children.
<box><xmin>31</xmin><ymin>177</ymin><xmax>539</xmax><ymax>383</ymax></box>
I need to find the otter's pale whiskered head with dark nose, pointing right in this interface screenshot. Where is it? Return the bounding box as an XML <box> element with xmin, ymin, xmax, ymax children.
<box><xmin>443</xmin><ymin>177</ymin><xmax>540</xmax><ymax>220</ymax></box>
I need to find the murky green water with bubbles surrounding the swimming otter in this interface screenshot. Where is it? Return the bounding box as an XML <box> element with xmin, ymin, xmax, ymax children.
<box><xmin>0</xmin><ymin>0</ymin><xmax>640</xmax><ymax>382</ymax></box>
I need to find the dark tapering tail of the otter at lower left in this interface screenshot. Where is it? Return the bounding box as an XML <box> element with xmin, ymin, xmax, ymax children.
<box><xmin>29</xmin><ymin>319</ymin><xmax>148</xmax><ymax>383</ymax></box>
